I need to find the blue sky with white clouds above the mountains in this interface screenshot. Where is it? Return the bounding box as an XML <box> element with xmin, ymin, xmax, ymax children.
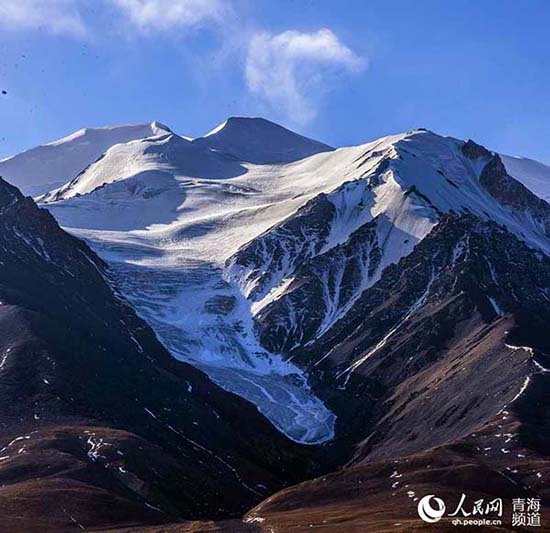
<box><xmin>0</xmin><ymin>0</ymin><xmax>550</xmax><ymax>163</ymax></box>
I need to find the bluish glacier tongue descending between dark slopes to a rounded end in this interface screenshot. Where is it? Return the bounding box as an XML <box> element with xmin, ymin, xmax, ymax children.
<box><xmin>61</xmin><ymin>225</ymin><xmax>335</xmax><ymax>444</ymax></box>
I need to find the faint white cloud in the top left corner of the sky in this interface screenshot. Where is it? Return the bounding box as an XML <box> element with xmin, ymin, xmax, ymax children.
<box><xmin>0</xmin><ymin>0</ymin><xmax>87</xmax><ymax>37</ymax></box>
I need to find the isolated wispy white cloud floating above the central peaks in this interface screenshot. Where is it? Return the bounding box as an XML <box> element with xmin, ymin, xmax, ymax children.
<box><xmin>245</xmin><ymin>28</ymin><xmax>366</xmax><ymax>124</ymax></box>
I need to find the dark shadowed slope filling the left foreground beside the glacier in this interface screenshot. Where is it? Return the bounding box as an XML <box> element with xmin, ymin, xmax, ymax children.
<box><xmin>0</xmin><ymin>180</ymin><xmax>326</xmax><ymax>531</ymax></box>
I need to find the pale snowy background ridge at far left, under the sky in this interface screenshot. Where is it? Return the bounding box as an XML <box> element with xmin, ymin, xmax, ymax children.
<box><xmin>0</xmin><ymin>122</ymin><xmax>169</xmax><ymax>196</ymax></box>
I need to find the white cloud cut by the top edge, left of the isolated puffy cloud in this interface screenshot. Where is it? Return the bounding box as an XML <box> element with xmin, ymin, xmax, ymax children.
<box><xmin>111</xmin><ymin>0</ymin><xmax>230</xmax><ymax>31</ymax></box>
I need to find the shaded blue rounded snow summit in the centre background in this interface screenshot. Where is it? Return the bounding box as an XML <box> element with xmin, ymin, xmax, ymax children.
<box><xmin>193</xmin><ymin>117</ymin><xmax>334</xmax><ymax>164</ymax></box>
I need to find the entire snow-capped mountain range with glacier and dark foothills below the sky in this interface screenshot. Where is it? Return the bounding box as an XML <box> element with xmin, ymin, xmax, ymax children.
<box><xmin>0</xmin><ymin>118</ymin><xmax>550</xmax><ymax>531</ymax></box>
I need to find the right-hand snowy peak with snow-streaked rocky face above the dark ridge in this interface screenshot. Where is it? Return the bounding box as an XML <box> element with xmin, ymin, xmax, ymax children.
<box><xmin>227</xmin><ymin>130</ymin><xmax>550</xmax><ymax>353</ymax></box>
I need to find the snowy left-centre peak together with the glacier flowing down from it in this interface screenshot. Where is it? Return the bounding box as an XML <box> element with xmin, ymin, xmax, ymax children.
<box><xmin>42</xmin><ymin>119</ymin><xmax>344</xmax><ymax>443</ymax></box>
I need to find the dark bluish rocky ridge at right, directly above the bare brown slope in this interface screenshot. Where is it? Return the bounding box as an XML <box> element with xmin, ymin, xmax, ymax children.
<box><xmin>300</xmin><ymin>215</ymin><xmax>550</xmax><ymax>444</ymax></box>
